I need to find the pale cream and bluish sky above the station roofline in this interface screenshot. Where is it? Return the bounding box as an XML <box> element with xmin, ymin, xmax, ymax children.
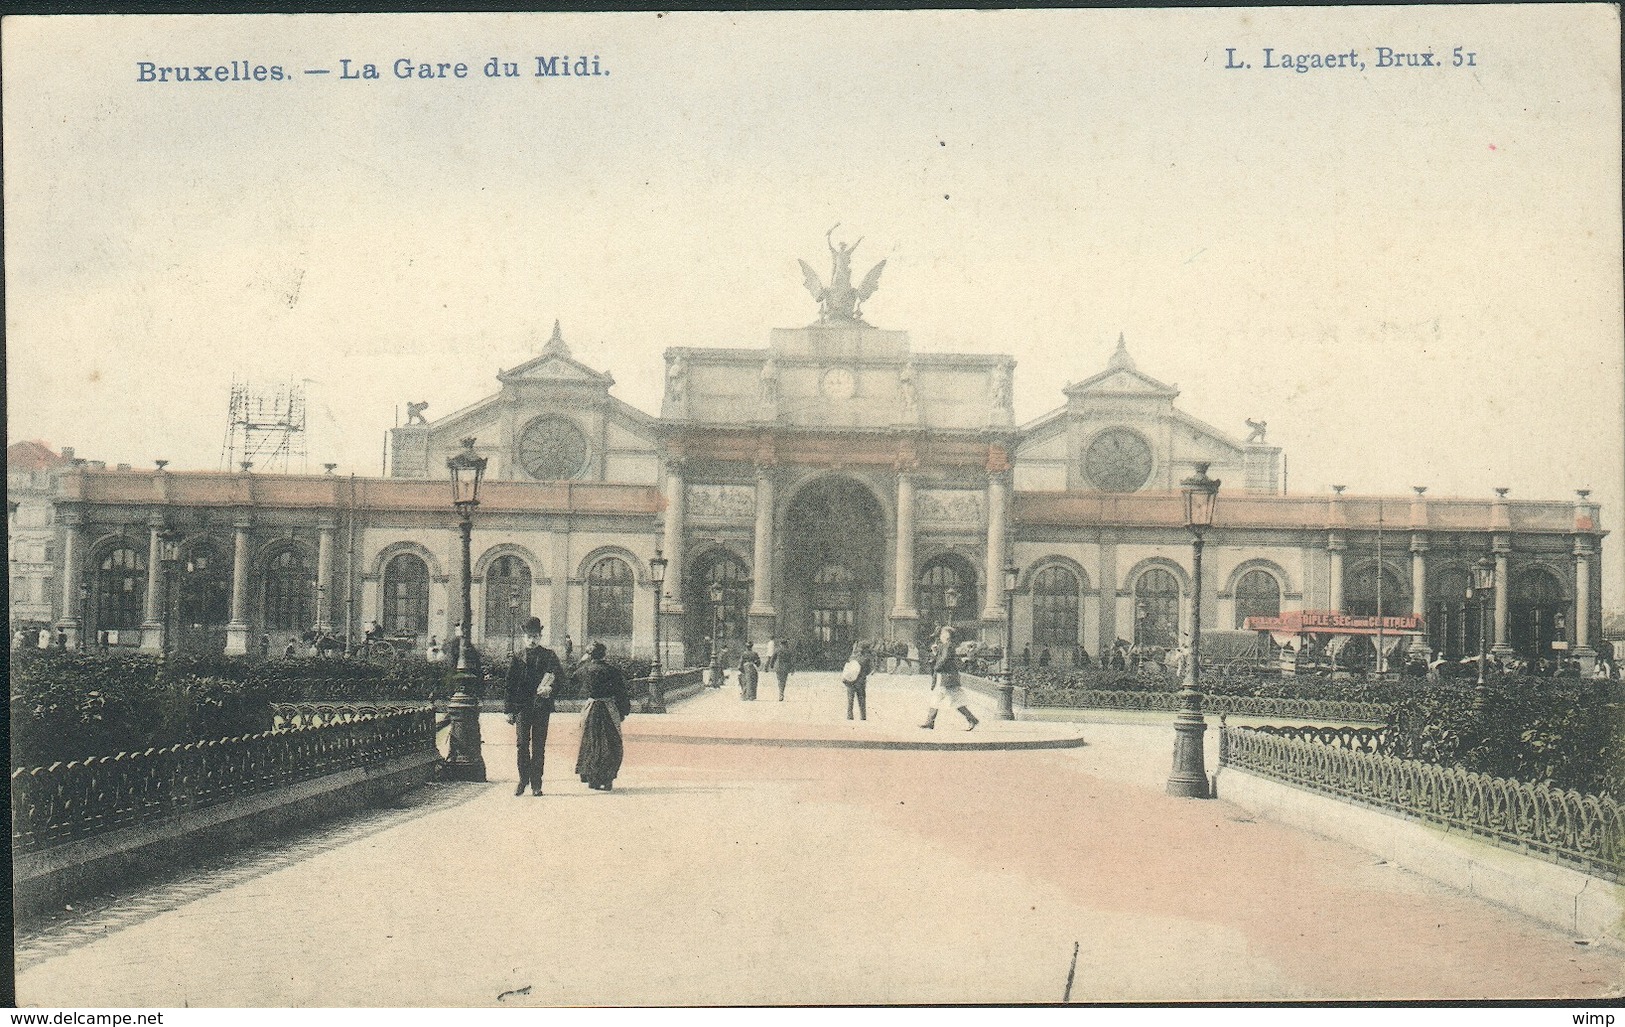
<box><xmin>9</xmin><ymin>5</ymin><xmax>1625</xmax><ymax>608</ymax></box>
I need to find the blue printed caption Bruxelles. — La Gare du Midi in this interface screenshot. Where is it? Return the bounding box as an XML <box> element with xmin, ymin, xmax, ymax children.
<box><xmin>135</xmin><ymin>54</ymin><xmax>609</xmax><ymax>83</ymax></box>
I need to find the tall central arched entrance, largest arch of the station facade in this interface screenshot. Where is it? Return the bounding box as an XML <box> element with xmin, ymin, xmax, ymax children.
<box><xmin>780</xmin><ymin>478</ymin><xmax>886</xmax><ymax>670</ymax></box>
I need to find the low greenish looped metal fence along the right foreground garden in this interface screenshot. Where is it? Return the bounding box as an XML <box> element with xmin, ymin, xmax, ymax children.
<box><xmin>1219</xmin><ymin>726</ymin><xmax>1625</xmax><ymax>881</ymax></box>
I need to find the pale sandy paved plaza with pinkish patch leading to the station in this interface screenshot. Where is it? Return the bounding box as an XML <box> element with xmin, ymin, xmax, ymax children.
<box><xmin>18</xmin><ymin>673</ymin><xmax>1625</xmax><ymax>1008</ymax></box>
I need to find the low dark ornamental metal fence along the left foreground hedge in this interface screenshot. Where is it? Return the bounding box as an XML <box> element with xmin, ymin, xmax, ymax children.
<box><xmin>11</xmin><ymin>707</ymin><xmax>434</xmax><ymax>853</ymax></box>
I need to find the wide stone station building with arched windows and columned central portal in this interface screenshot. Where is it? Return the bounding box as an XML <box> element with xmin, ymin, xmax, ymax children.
<box><xmin>13</xmin><ymin>273</ymin><xmax>1604</xmax><ymax>666</ymax></box>
